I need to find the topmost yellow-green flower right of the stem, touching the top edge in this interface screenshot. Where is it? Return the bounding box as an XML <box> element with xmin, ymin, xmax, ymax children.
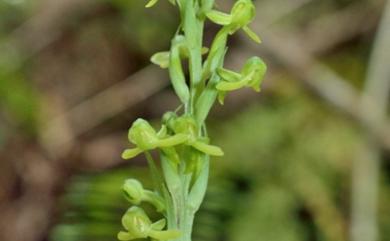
<box><xmin>206</xmin><ymin>0</ymin><xmax>261</xmax><ymax>43</ymax></box>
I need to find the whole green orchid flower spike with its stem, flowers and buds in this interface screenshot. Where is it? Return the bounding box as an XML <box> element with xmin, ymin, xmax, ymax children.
<box><xmin>118</xmin><ymin>0</ymin><xmax>266</xmax><ymax>241</ymax></box>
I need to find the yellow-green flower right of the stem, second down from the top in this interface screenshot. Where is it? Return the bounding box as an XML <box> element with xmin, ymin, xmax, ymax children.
<box><xmin>216</xmin><ymin>57</ymin><xmax>267</xmax><ymax>103</ymax></box>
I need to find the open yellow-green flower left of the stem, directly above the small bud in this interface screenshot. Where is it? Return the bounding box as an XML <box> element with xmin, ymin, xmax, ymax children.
<box><xmin>122</xmin><ymin>118</ymin><xmax>187</xmax><ymax>159</ymax></box>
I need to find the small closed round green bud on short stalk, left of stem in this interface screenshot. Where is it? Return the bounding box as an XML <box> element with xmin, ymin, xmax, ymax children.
<box><xmin>123</xmin><ymin>179</ymin><xmax>165</xmax><ymax>212</ymax></box>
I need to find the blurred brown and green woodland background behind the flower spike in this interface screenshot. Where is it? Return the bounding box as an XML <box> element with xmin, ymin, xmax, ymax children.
<box><xmin>0</xmin><ymin>0</ymin><xmax>390</xmax><ymax>241</ymax></box>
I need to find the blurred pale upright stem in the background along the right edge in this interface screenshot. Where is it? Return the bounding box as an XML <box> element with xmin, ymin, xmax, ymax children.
<box><xmin>350</xmin><ymin>2</ymin><xmax>390</xmax><ymax>241</ymax></box>
